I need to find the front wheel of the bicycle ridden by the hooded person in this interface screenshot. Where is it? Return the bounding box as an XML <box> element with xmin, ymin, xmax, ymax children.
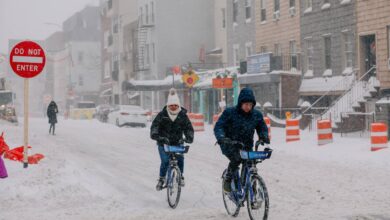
<box><xmin>247</xmin><ymin>175</ymin><xmax>269</xmax><ymax>220</ymax></box>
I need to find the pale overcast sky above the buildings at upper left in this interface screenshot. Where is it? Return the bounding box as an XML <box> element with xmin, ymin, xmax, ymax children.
<box><xmin>0</xmin><ymin>0</ymin><xmax>99</xmax><ymax>53</ymax></box>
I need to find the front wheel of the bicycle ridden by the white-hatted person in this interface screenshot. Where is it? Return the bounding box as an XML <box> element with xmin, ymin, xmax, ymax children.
<box><xmin>167</xmin><ymin>167</ymin><xmax>181</xmax><ymax>209</ymax></box>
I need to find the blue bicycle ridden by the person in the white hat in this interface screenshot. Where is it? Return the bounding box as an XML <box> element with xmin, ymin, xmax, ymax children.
<box><xmin>163</xmin><ymin>145</ymin><xmax>189</xmax><ymax>209</ymax></box>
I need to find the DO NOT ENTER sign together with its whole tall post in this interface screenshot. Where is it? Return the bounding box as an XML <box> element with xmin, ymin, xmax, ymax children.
<box><xmin>9</xmin><ymin>41</ymin><xmax>46</xmax><ymax>168</ymax></box>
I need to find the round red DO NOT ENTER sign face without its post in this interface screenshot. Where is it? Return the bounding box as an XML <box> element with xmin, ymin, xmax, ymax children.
<box><xmin>9</xmin><ymin>41</ymin><xmax>46</xmax><ymax>78</ymax></box>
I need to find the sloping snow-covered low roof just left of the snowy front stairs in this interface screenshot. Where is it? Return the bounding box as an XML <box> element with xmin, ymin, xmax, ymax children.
<box><xmin>299</xmin><ymin>75</ymin><xmax>355</xmax><ymax>93</ymax></box>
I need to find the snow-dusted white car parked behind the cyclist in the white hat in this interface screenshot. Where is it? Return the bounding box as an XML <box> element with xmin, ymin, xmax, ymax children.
<box><xmin>108</xmin><ymin>105</ymin><xmax>148</xmax><ymax>127</ymax></box>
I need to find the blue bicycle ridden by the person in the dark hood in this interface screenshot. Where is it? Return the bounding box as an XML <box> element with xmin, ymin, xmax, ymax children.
<box><xmin>222</xmin><ymin>142</ymin><xmax>272</xmax><ymax>220</ymax></box>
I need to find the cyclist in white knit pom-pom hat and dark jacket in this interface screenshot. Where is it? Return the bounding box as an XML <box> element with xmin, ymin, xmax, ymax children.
<box><xmin>150</xmin><ymin>88</ymin><xmax>194</xmax><ymax>191</ymax></box>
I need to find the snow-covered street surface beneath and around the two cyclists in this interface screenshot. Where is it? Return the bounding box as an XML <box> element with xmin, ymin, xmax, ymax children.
<box><xmin>0</xmin><ymin>118</ymin><xmax>390</xmax><ymax>220</ymax></box>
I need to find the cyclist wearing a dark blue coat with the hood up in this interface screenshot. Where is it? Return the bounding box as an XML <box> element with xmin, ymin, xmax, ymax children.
<box><xmin>214</xmin><ymin>88</ymin><xmax>270</xmax><ymax>192</ymax></box>
